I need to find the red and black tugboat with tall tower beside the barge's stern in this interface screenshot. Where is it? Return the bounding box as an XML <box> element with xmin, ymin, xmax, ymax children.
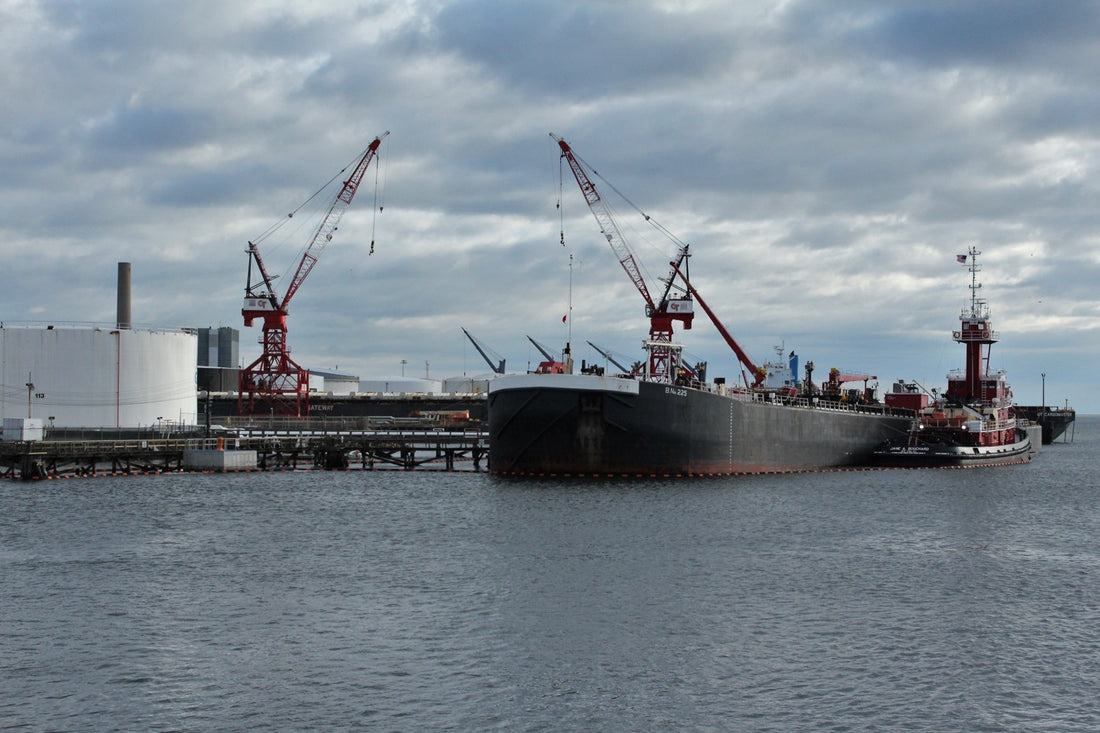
<box><xmin>875</xmin><ymin>247</ymin><xmax>1032</xmax><ymax>468</ymax></box>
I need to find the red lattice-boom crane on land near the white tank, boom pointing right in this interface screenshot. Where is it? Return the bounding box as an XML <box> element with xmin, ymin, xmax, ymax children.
<box><xmin>237</xmin><ymin>131</ymin><xmax>389</xmax><ymax>417</ymax></box>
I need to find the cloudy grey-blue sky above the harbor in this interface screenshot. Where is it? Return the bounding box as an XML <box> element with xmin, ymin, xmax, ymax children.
<box><xmin>0</xmin><ymin>0</ymin><xmax>1100</xmax><ymax>413</ymax></box>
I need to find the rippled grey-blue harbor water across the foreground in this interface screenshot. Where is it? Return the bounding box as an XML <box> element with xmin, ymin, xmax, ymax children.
<box><xmin>0</xmin><ymin>416</ymin><xmax>1100</xmax><ymax>731</ymax></box>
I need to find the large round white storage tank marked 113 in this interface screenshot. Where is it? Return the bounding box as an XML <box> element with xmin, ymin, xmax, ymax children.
<box><xmin>0</xmin><ymin>326</ymin><xmax>198</xmax><ymax>428</ymax></box>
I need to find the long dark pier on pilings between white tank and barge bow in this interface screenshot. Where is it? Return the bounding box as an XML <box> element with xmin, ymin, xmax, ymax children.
<box><xmin>0</xmin><ymin>418</ymin><xmax>488</xmax><ymax>480</ymax></box>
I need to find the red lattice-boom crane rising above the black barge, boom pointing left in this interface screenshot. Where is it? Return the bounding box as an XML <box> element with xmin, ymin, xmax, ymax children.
<box><xmin>550</xmin><ymin>132</ymin><xmax>695</xmax><ymax>382</ymax></box>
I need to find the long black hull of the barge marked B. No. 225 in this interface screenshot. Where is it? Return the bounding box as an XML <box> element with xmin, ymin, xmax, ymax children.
<box><xmin>488</xmin><ymin>374</ymin><xmax>912</xmax><ymax>475</ymax></box>
